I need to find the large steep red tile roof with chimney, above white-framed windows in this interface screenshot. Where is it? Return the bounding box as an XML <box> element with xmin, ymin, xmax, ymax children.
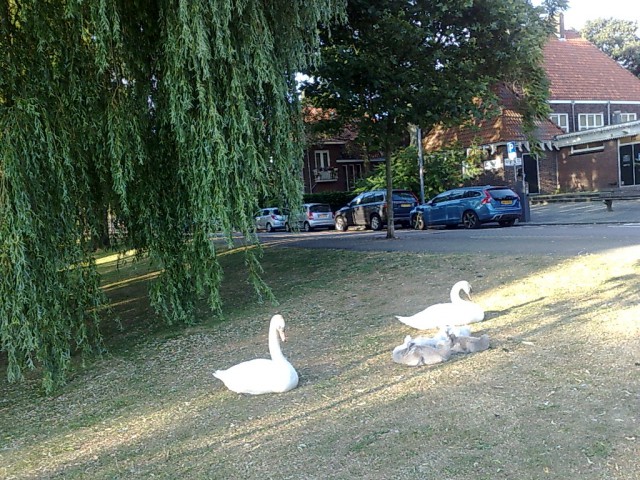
<box><xmin>544</xmin><ymin>30</ymin><xmax>640</xmax><ymax>101</ymax></box>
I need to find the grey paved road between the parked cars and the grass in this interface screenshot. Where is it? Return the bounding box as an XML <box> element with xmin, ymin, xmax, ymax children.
<box><xmin>255</xmin><ymin>200</ymin><xmax>640</xmax><ymax>256</ymax></box>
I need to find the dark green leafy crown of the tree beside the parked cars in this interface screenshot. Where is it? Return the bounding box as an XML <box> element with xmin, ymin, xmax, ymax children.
<box><xmin>304</xmin><ymin>0</ymin><xmax>566</xmax><ymax>236</ymax></box>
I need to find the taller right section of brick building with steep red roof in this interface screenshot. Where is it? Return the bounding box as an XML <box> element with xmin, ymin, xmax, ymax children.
<box><xmin>544</xmin><ymin>19</ymin><xmax>640</xmax><ymax>191</ymax></box>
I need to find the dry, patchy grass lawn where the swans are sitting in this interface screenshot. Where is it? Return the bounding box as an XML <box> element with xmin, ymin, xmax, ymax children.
<box><xmin>0</xmin><ymin>247</ymin><xmax>640</xmax><ymax>480</ymax></box>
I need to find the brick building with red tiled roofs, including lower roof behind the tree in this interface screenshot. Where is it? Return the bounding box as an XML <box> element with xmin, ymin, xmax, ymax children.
<box><xmin>424</xmin><ymin>18</ymin><xmax>640</xmax><ymax>194</ymax></box>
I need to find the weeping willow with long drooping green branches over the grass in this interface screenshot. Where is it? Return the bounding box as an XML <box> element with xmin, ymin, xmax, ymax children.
<box><xmin>0</xmin><ymin>0</ymin><xmax>344</xmax><ymax>391</ymax></box>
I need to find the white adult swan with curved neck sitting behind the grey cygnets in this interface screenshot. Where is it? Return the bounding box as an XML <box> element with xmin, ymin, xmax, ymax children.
<box><xmin>396</xmin><ymin>280</ymin><xmax>484</xmax><ymax>330</ymax></box>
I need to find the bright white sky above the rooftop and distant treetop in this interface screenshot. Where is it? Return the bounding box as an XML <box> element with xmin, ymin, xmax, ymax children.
<box><xmin>534</xmin><ymin>0</ymin><xmax>640</xmax><ymax>30</ymax></box>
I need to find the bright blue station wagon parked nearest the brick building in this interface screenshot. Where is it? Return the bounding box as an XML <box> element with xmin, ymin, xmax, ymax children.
<box><xmin>410</xmin><ymin>185</ymin><xmax>522</xmax><ymax>230</ymax></box>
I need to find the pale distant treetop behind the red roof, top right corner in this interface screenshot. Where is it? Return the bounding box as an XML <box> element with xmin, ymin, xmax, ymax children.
<box><xmin>581</xmin><ymin>18</ymin><xmax>640</xmax><ymax>77</ymax></box>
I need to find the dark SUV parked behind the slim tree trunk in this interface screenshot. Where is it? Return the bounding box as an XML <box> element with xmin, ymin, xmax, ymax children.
<box><xmin>335</xmin><ymin>190</ymin><xmax>418</xmax><ymax>231</ymax></box>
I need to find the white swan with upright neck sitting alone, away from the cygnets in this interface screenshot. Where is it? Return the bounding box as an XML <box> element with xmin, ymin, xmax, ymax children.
<box><xmin>213</xmin><ymin>315</ymin><xmax>298</xmax><ymax>395</ymax></box>
